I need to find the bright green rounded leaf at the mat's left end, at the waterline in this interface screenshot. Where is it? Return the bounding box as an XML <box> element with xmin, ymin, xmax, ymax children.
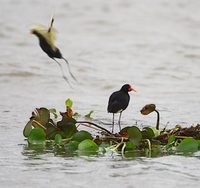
<box><xmin>28</xmin><ymin>128</ymin><xmax>46</xmax><ymax>145</ymax></box>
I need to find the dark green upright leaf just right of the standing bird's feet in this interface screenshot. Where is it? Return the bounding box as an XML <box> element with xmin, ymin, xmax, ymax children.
<box><xmin>127</xmin><ymin>126</ymin><xmax>142</xmax><ymax>146</ymax></box>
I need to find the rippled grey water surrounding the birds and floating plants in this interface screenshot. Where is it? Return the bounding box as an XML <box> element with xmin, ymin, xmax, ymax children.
<box><xmin>0</xmin><ymin>0</ymin><xmax>200</xmax><ymax>188</ymax></box>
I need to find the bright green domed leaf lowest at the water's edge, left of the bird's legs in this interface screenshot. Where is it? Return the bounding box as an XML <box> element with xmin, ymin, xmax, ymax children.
<box><xmin>78</xmin><ymin>139</ymin><xmax>99</xmax><ymax>154</ymax></box>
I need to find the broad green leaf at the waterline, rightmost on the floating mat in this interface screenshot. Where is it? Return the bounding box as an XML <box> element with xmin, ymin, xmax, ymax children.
<box><xmin>176</xmin><ymin>138</ymin><xmax>199</xmax><ymax>153</ymax></box>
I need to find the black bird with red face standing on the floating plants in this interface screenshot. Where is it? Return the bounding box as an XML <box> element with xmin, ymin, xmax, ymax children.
<box><xmin>107</xmin><ymin>84</ymin><xmax>136</xmax><ymax>133</ymax></box>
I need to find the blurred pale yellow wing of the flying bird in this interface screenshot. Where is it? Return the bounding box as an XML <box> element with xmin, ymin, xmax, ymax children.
<box><xmin>31</xmin><ymin>25</ymin><xmax>56</xmax><ymax>49</ymax></box>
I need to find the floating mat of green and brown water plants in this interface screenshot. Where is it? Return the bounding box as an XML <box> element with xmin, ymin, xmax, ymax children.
<box><xmin>23</xmin><ymin>99</ymin><xmax>200</xmax><ymax>158</ymax></box>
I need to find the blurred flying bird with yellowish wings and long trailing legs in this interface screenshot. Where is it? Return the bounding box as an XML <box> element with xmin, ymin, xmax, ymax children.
<box><xmin>31</xmin><ymin>18</ymin><xmax>77</xmax><ymax>84</ymax></box>
